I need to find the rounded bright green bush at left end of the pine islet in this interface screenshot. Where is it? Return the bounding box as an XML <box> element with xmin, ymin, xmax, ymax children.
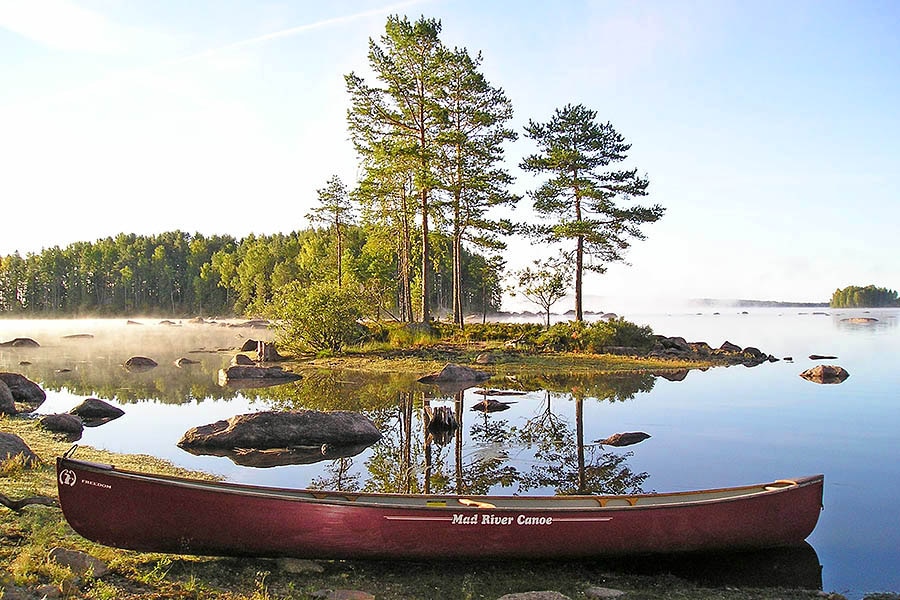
<box><xmin>269</xmin><ymin>281</ymin><xmax>366</xmax><ymax>352</ymax></box>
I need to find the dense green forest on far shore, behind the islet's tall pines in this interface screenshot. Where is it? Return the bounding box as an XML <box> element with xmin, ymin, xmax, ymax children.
<box><xmin>0</xmin><ymin>225</ymin><xmax>501</xmax><ymax>317</ymax></box>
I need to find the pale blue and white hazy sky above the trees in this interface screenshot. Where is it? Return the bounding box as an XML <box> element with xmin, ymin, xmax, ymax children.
<box><xmin>0</xmin><ymin>0</ymin><xmax>900</xmax><ymax>310</ymax></box>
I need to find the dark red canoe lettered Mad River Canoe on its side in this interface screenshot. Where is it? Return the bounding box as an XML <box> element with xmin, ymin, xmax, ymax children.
<box><xmin>56</xmin><ymin>458</ymin><xmax>823</xmax><ymax>559</ymax></box>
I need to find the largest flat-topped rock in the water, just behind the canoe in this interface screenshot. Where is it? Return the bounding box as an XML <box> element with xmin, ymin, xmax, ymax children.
<box><xmin>178</xmin><ymin>410</ymin><xmax>381</xmax><ymax>449</ymax></box>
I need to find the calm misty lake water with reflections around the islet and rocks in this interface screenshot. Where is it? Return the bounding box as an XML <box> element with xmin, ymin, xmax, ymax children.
<box><xmin>0</xmin><ymin>307</ymin><xmax>900</xmax><ymax>598</ymax></box>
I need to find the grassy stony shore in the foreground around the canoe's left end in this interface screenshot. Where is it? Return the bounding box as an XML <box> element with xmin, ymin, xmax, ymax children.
<box><xmin>0</xmin><ymin>417</ymin><xmax>872</xmax><ymax>600</ymax></box>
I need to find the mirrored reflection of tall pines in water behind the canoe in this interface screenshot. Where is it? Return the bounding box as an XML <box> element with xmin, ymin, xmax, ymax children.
<box><xmin>338</xmin><ymin>374</ymin><xmax>654</xmax><ymax>495</ymax></box>
